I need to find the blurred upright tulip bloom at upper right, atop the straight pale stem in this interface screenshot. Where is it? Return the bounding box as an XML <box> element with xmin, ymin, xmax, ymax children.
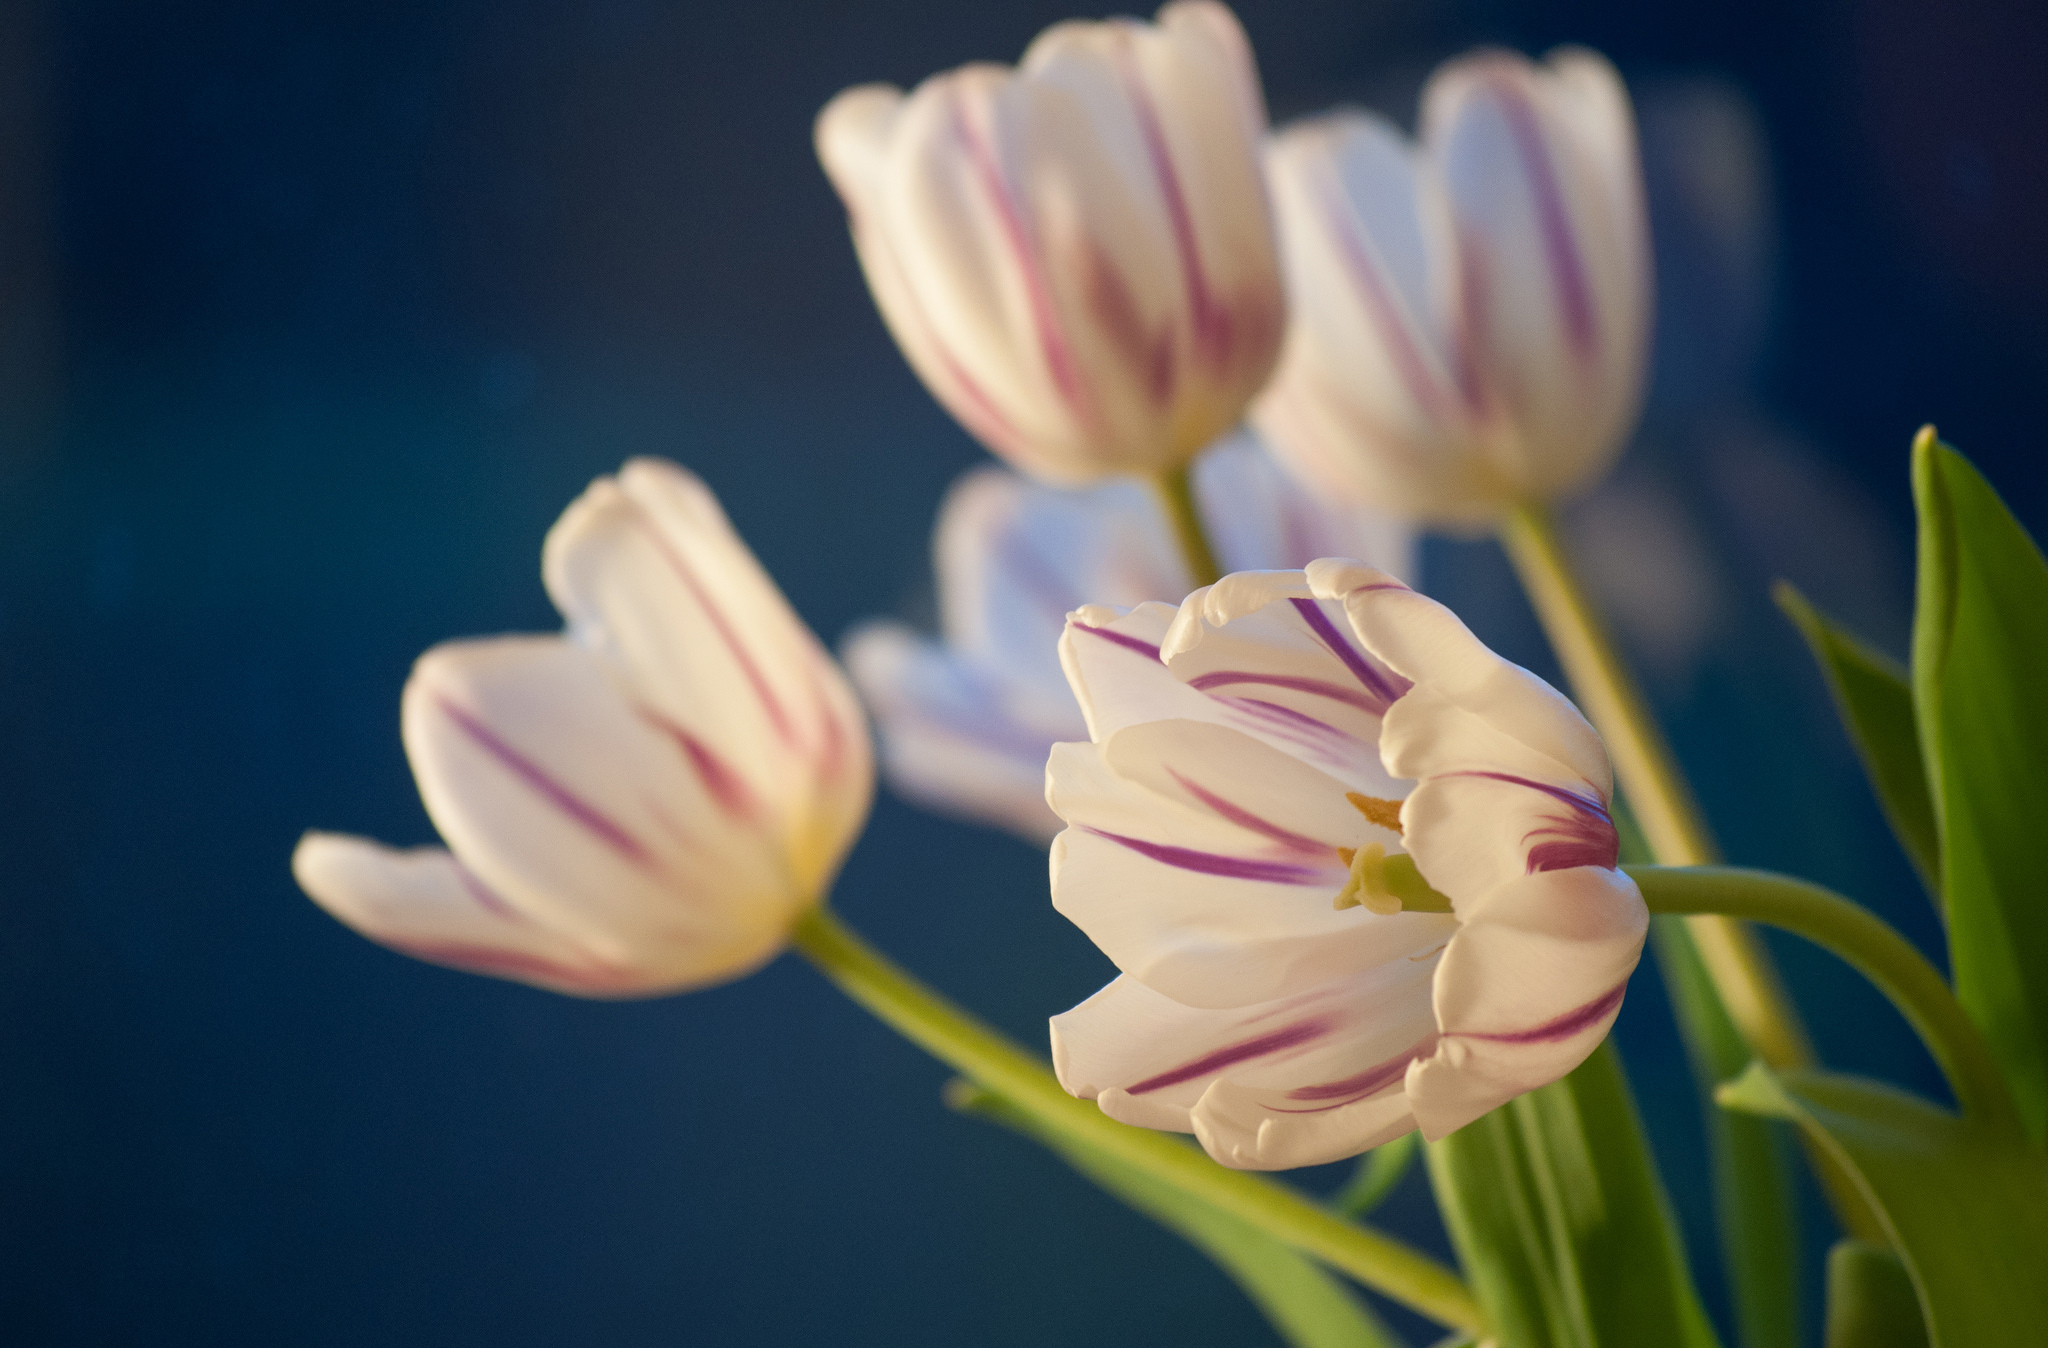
<box><xmin>1253</xmin><ymin>49</ymin><xmax>1651</xmax><ymax>524</ymax></box>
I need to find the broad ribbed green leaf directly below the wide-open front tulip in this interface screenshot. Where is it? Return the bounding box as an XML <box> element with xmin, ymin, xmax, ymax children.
<box><xmin>1427</xmin><ymin>1045</ymin><xmax>1716</xmax><ymax>1348</ymax></box>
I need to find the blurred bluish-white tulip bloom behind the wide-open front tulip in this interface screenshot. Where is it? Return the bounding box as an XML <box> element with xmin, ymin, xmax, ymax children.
<box><xmin>846</xmin><ymin>436</ymin><xmax>1413</xmax><ymax>844</ymax></box>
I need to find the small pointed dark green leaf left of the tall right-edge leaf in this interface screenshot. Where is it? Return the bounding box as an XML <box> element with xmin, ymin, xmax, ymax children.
<box><xmin>1772</xmin><ymin>580</ymin><xmax>1942</xmax><ymax>893</ymax></box>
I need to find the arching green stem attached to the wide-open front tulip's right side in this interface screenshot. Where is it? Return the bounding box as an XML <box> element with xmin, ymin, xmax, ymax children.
<box><xmin>1624</xmin><ymin>867</ymin><xmax>2021</xmax><ymax>1133</ymax></box>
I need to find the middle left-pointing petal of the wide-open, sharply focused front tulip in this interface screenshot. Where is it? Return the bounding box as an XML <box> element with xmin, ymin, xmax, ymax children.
<box><xmin>1047</xmin><ymin>721</ymin><xmax>1454</xmax><ymax>1008</ymax></box>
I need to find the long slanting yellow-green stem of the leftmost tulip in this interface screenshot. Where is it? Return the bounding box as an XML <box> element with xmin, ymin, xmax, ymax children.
<box><xmin>791</xmin><ymin>905</ymin><xmax>1487</xmax><ymax>1336</ymax></box>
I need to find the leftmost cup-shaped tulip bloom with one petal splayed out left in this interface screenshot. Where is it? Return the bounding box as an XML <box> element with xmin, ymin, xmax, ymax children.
<box><xmin>293</xmin><ymin>459</ymin><xmax>874</xmax><ymax>998</ymax></box>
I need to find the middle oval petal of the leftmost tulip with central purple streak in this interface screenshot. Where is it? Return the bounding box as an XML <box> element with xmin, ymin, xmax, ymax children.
<box><xmin>401</xmin><ymin>637</ymin><xmax>790</xmax><ymax>985</ymax></box>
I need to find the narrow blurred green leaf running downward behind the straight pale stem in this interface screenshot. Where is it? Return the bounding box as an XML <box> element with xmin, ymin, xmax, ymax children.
<box><xmin>1651</xmin><ymin>914</ymin><xmax>1800</xmax><ymax>1348</ymax></box>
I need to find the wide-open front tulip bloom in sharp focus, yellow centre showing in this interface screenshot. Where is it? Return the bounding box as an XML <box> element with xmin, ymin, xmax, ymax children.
<box><xmin>1047</xmin><ymin>561</ymin><xmax>1649</xmax><ymax>1170</ymax></box>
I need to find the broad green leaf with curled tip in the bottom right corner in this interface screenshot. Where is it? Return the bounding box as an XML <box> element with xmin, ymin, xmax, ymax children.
<box><xmin>1720</xmin><ymin>1063</ymin><xmax>2048</xmax><ymax>1348</ymax></box>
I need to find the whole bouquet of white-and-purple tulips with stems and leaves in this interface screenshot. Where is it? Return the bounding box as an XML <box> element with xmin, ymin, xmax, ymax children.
<box><xmin>293</xmin><ymin>0</ymin><xmax>2048</xmax><ymax>1348</ymax></box>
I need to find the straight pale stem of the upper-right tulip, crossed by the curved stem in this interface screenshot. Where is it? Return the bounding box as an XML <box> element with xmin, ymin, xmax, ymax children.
<box><xmin>1501</xmin><ymin>493</ymin><xmax>1812</xmax><ymax>1069</ymax></box>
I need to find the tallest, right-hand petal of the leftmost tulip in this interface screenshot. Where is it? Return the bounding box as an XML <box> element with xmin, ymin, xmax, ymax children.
<box><xmin>543</xmin><ymin>459</ymin><xmax>872</xmax><ymax>889</ymax></box>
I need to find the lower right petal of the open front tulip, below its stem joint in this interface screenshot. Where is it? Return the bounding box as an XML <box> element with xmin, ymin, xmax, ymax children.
<box><xmin>1407</xmin><ymin>867</ymin><xmax>1649</xmax><ymax>1141</ymax></box>
